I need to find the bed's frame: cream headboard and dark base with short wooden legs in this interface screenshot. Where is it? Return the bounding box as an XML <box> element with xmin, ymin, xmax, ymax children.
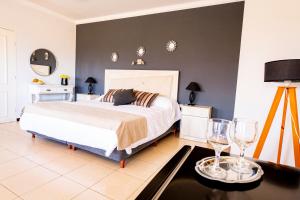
<box><xmin>28</xmin><ymin>69</ymin><xmax>179</xmax><ymax>168</ymax></box>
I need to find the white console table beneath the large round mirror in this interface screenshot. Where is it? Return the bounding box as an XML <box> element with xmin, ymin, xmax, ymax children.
<box><xmin>29</xmin><ymin>84</ymin><xmax>74</xmax><ymax>103</ymax></box>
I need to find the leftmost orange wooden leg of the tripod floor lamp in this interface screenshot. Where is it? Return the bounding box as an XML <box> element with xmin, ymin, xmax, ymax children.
<box><xmin>253</xmin><ymin>87</ymin><xmax>285</xmax><ymax>159</ymax></box>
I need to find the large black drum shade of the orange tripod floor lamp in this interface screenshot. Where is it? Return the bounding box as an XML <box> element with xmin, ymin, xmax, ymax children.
<box><xmin>265</xmin><ymin>59</ymin><xmax>300</xmax><ymax>82</ymax></box>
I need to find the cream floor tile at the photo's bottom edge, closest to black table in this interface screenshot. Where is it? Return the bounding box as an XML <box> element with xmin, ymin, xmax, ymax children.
<box><xmin>91</xmin><ymin>172</ymin><xmax>143</xmax><ymax>200</ymax></box>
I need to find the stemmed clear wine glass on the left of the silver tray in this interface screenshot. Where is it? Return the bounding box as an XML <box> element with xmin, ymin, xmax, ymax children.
<box><xmin>205</xmin><ymin>119</ymin><xmax>232</xmax><ymax>179</ymax></box>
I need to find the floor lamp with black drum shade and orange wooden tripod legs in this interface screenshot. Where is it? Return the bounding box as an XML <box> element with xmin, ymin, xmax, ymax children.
<box><xmin>253</xmin><ymin>59</ymin><xmax>300</xmax><ymax>168</ymax></box>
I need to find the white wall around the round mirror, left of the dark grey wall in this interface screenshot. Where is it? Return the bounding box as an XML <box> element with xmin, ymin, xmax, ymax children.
<box><xmin>0</xmin><ymin>0</ymin><xmax>76</xmax><ymax>114</ymax></box>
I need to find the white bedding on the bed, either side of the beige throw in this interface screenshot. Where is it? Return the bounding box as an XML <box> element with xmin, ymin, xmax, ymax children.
<box><xmin>20</xmin><ymin>96</ymin><xmax>181</xmax><ymax>156</ymax></box>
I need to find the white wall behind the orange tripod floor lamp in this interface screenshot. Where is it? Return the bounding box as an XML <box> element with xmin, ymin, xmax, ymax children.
<box><xmin>235</xmin><ymin>0</ymin><xmax>300</xmax><ymax>165</ymax></box>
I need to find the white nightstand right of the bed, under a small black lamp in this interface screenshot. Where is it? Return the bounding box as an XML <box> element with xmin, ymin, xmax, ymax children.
<box><xmin>180</xmin><ymin>104</ymin><xmax>212</xmax><ymax>142</ymax></box>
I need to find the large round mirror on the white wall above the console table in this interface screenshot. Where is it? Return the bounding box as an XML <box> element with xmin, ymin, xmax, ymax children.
<box><xmin>30</xmin><ymin>49</ymin><xmax>56</xmax><ymax>76</ymax></box>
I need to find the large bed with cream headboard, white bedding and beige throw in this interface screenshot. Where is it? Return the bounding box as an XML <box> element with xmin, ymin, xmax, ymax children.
<box><xmin>20</xmin><ymin>70</ymin><xmax>180</xmax><ymax>168</ymax></box>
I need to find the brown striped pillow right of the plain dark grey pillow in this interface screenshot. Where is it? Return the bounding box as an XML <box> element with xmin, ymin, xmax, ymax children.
<box><xmin>132</xmin><ymin>90</ymin><xmax>159</xmax><ymax>107</ymax></box>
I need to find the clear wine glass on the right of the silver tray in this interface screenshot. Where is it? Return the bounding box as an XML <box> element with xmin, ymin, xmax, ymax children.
<box><xmin>230</xmin><ymin>118</ymin><xmax>258</xmax><ymax>174</ymax></box>
